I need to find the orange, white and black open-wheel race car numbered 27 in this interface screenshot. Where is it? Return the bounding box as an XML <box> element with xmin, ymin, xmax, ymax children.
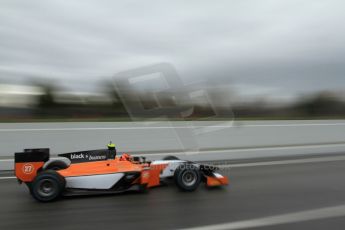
<box><xmin>14</xmin><ymin>143</ymin><xmax>229</xmax><ymax>202</ymax></box>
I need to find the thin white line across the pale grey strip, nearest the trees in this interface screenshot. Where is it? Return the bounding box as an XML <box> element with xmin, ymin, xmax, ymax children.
<box><xmin>0</xmin><ymin>123</ymin><xmax>345</xmax><ymax>132</ymax></box>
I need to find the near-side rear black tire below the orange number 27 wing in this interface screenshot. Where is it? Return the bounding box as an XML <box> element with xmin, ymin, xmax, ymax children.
<box><xmin>31</xmin><ymin>170</ymin><xmax>65</xmax><ymax>202</ymax></box>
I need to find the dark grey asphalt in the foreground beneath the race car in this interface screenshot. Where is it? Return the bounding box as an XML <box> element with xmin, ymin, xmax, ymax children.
<box><xmin>0</xmin><ymin>155</ymin><xmax>345</xmax><ymax>230</ymax></box>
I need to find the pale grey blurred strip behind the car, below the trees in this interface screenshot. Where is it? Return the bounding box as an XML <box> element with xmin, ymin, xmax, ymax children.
<box><xmin>0</xmin><ymin>120</ymin><xmax>345</xmax><ymax>170</ymax></box>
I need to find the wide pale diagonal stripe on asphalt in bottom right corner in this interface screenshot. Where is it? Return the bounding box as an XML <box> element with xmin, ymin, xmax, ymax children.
<box><xmin>181</xmin><ymin>205</ymin><xmax>345</xmax><ymax>230</ymax></box>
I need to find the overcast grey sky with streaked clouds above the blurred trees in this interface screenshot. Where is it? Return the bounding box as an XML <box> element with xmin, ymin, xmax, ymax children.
<box><xmin>0</xmin><ymin>0</ymin><xmax>345</xmax><ymax>94</ymax></box>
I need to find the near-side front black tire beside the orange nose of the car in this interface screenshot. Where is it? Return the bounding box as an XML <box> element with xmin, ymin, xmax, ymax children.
<box><xmin>174</xmin><ymin>164</ymin><xmax>201</xmax><ymax>192</ymax></box>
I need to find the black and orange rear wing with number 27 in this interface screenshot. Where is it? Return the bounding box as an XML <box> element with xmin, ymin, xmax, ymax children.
<box><xmin>14</xmin><ymin>148</ymin><xmax>49</xmax><ymax>182</ymax></box>
